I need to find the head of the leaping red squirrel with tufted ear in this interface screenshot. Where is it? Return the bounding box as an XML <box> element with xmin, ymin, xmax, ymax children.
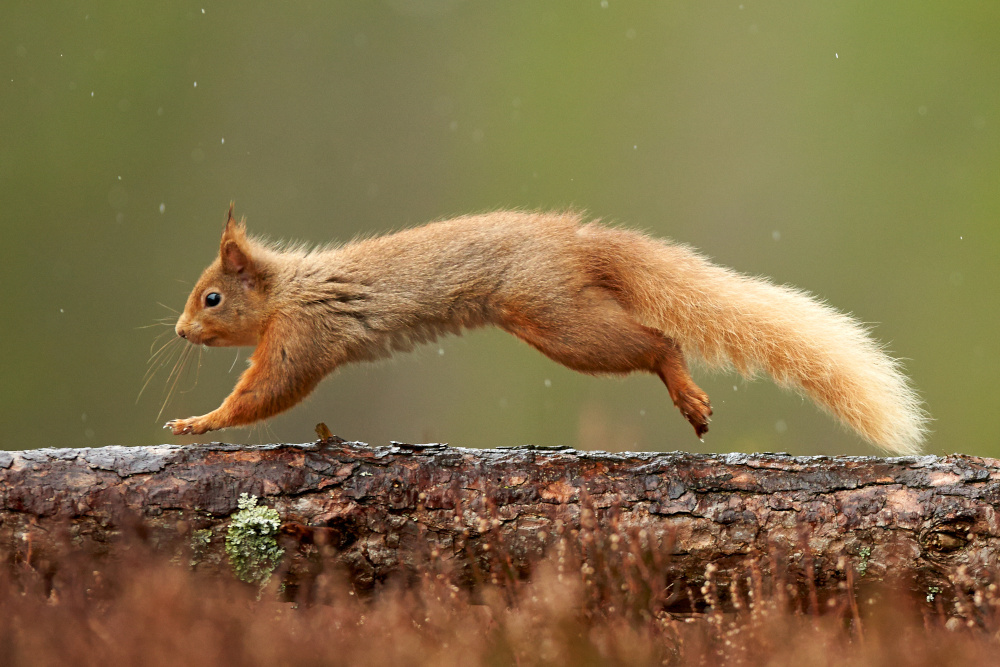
<box><xmin>174</xmin><ymin>204</ymin><xmax>268</xmax><ymax>347</ymax></box>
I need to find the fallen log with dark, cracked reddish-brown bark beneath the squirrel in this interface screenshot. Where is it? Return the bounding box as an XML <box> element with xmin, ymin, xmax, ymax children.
<box><xmin>0</xmin><ymin>438</ymin><xmax>1000</xmax><ymax>605</ymax></box>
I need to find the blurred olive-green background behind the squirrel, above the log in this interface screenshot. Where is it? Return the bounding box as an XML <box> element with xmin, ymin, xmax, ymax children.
<box><xmin>0</xmin><ymin>0</ymin><xmax>1000</xmax><ymax>456</ymax></box>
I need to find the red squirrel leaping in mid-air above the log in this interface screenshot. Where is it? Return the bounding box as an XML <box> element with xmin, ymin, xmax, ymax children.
<box><xmin>165</xmin><ymin>206</ymin><xmax>927</xmax><ymax>454</ymax></box>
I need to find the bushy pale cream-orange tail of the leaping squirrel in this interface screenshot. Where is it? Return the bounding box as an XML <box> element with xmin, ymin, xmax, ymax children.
<box><xmin>580</xmin><ymin>225</ymin><xmax>928</xmax><ymax>454</ymax></box>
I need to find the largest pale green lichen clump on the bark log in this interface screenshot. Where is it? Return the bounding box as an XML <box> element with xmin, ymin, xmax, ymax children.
<box><xmin>226</xmin><ymin>493</ymin><xmax>285</xmax><ymax>587</ymax></box>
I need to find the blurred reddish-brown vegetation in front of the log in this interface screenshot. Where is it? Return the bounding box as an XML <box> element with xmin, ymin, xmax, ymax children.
<box><xmin>0</xmin><ymin>530</ymin><xmax>1000</xmax><ymax>667</ymax></box>
